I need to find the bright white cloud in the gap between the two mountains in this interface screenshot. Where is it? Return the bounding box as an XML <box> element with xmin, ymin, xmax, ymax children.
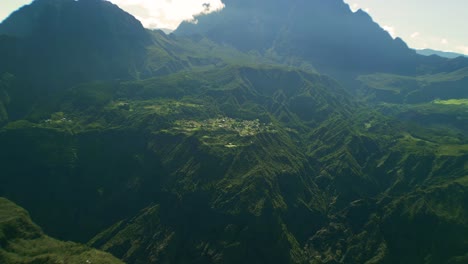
<box><xmin>108</xmin><ymin>0</ymin><xmax>224</xmax><ymax>29</ymax></box>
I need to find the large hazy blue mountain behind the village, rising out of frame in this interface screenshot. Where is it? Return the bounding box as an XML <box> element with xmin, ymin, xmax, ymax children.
<box><xmin>174</xmin><ymin>0</ymin><xmax>416</xmax><ymax>74</ymax></box>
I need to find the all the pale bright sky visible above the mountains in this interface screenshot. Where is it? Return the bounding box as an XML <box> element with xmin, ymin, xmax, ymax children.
<box><xmin>0</xmin><ymin>0</ymin><xmax>468</xmax><ymax>54</ymax></box>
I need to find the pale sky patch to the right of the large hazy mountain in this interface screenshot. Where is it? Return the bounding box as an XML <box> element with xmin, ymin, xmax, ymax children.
<box><xmin>345</xmin><ymin>0</ymin><xmax>468</xmax><ymax>54</ymax></box>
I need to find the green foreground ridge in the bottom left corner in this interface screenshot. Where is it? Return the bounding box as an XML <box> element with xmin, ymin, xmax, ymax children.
<box><xmin>0</xmin><ymin>198</ymin><xmax>122</xmax><ymax>264</ymax></box>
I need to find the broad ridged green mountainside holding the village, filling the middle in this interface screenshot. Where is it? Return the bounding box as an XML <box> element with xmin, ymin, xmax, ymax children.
<box><xmin>0</xmin><ymin>63</ymin><xmax>466</xmax><ymax>263</ymax></box>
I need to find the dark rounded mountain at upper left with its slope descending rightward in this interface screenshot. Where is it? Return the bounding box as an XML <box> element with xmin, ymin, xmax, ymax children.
<box><xmin>0</xmin><ymin>0</ymin><xmax>196</xmax><ymax>120</ymax></box>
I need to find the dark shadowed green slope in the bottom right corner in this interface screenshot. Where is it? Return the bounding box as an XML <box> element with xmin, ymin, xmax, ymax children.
<box><xmin>306</xmin><ymin>173</ymin><xmax>467</xmax><ymax>263</ymax></box>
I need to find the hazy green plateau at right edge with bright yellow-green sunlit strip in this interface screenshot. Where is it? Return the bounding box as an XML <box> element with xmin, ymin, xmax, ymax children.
<box><xmin>359</xmin><ymin>68</ymin><xmax>468</xmax><ymax>147</ymax></box>
